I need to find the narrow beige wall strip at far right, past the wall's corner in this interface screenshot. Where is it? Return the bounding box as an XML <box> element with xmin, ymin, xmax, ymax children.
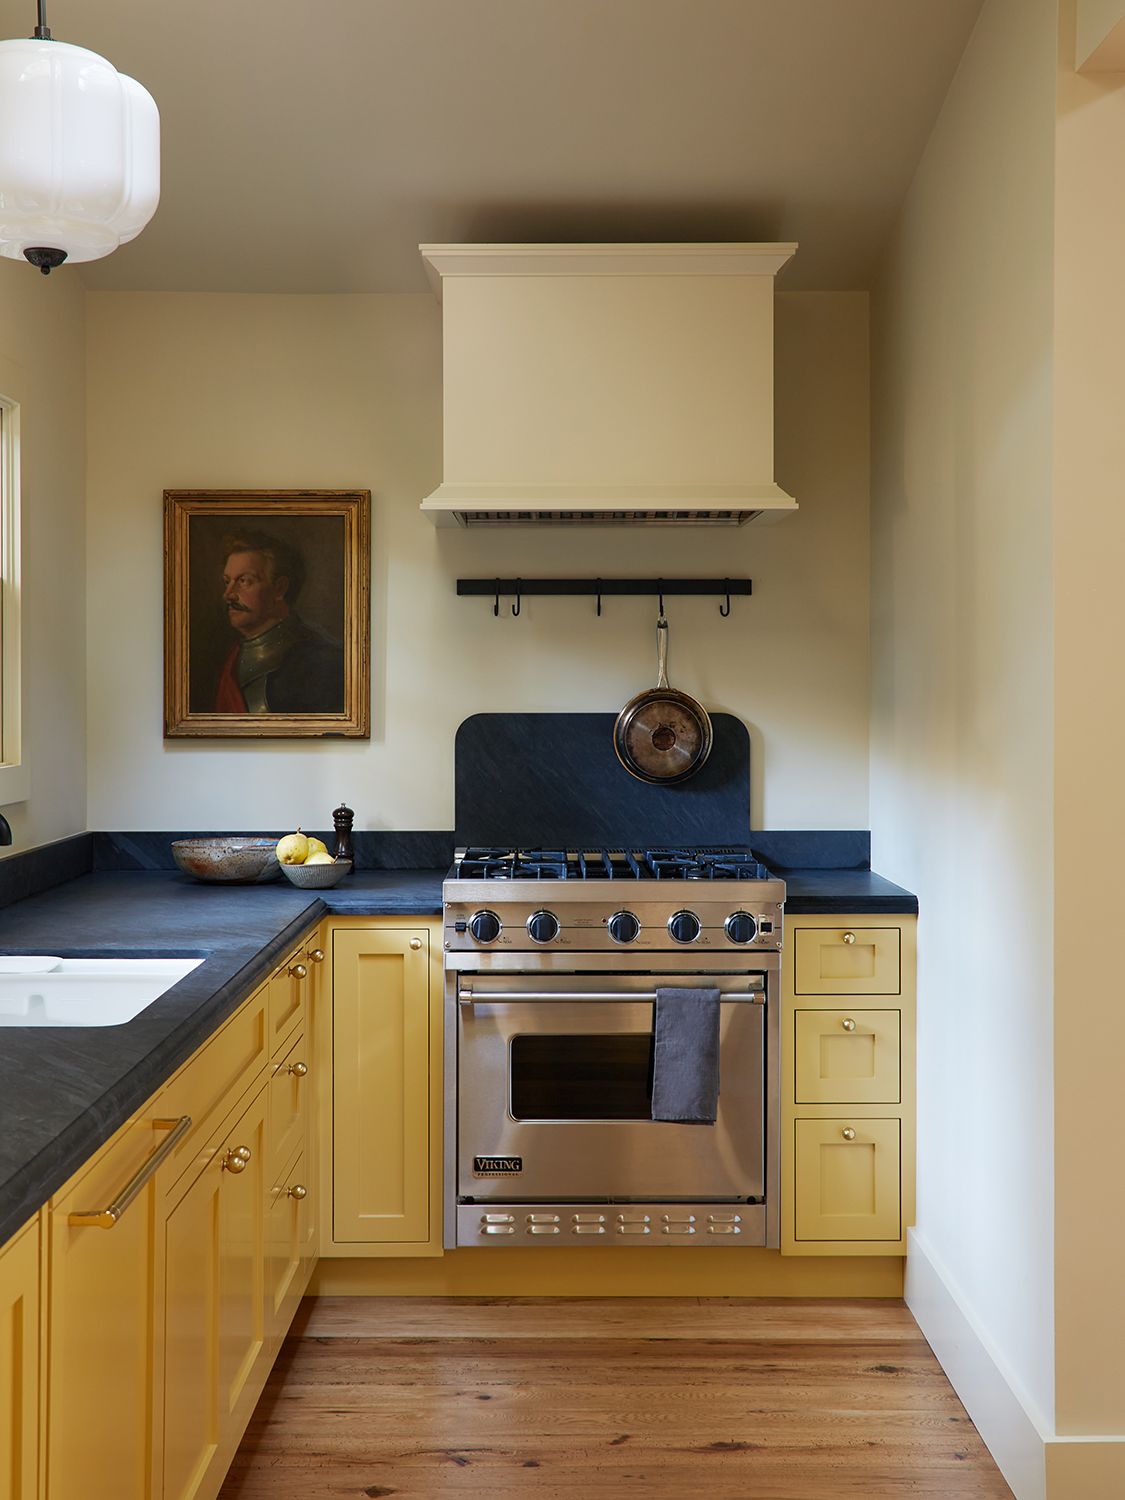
<box><xmin>1055</xmin><ymin>5</ymin><xmax>1125</xmax><ymax>1434</ymax></box>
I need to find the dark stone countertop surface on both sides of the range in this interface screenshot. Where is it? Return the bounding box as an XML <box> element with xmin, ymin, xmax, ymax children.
<box><xmin>0</xmin><ymin>869</ymin><xmax>918</xmax><ymax>1245</ymax></box>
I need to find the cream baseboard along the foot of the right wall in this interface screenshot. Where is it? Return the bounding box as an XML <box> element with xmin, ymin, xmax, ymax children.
<box><xmin>903</xmin><ymin>1230</ymin><xmax>1125</xmax><ymax>1500</ymax></box>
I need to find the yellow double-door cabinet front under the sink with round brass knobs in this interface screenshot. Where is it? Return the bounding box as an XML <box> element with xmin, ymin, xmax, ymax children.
<box><xmin>162</xmin><ymin>1083</ymin><xmax>270</xmax><ymax>1500</ymax></box>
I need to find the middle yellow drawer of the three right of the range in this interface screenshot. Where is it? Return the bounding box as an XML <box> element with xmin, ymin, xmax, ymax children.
<box><xmin>794</xmin><ymin>1007</ymin><xmax>902</xmax><ymax>1104</ymax></box>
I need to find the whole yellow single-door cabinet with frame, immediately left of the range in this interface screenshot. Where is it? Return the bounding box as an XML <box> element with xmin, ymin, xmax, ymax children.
<box><xmin>318</xmin><ymin>918</ymin><xmax>443</xmax><ymax>1256</ymax></box>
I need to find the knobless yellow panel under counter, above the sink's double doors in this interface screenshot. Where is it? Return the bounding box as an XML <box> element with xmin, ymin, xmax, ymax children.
<box><xmin>159</xmin><ymin>986</ymin><xmax>269</xmax><ymax>1190</ymax></box>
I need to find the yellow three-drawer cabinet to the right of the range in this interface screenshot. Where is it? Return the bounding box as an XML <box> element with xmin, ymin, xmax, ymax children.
<box><xmin>782</xmin><ymin>912</ymin><xmax>917</xmax><ymax>1256</ymax></box>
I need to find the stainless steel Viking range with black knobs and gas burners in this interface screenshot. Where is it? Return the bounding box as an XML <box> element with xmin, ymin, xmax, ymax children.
<box><xmin>444</xmin><ymin>848</ymin><xmax>785</xmax><ymax>1248</ymax></box>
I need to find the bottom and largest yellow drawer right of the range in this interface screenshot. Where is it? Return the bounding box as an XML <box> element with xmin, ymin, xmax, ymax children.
<box><xmin>794</xmin><ymin>1118</ymin><xmax>902</xmax><ymax>1241</ymax></box>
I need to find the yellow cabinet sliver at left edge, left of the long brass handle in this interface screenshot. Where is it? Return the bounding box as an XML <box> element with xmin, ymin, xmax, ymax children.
<box><xmin>0</xmin><ymin>1218</ymin><xmax>39</xmax><ymax>1500</ymax></box>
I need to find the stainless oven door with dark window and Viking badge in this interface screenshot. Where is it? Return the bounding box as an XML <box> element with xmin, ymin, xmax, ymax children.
<box><xmin>458</xmin><ymin>975</ymin><xmax>767</xmax><ymax>1203</ymax></box>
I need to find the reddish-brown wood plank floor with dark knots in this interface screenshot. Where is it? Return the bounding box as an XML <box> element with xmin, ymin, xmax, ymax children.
<box><xmin>219</xmin><ymin>1298</ymin><xmax>1011</xmax><ymax>1500</ymax></box>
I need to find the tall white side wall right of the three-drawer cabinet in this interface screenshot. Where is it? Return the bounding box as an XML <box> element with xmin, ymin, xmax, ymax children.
<box><xmin>872</xmin><ymin>0</ymin><xmax>1056</xmax><ymax>1437</ymax></box>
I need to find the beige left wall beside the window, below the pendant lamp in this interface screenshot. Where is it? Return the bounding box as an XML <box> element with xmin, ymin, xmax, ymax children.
<box><xmin>0</xmin><ymin>260</ymin><xmax>86</xmax><ymax>855</ymax></box>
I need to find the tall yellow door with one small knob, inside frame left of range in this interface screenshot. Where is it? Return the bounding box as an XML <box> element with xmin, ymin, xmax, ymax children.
<box><xmin>332</xmin><ymin>927</ymin><xmax>429</xmax><ymax>1244</ymax></box>
